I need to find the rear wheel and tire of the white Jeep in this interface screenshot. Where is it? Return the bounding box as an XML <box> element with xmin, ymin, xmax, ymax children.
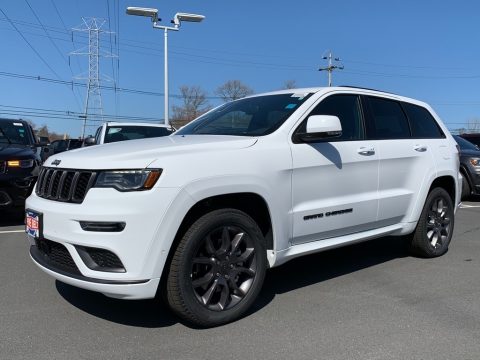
<box><xmin>408</xmin><ymin>188</ymin><xmax>455</xmax><ymax>258</ymax></box>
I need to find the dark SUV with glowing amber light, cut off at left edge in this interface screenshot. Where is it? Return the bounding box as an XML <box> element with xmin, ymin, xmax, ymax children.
<box><xmin>0</xmin><ymin>119</ymin><xmax>41</xmax><ymax>213</ymax></box>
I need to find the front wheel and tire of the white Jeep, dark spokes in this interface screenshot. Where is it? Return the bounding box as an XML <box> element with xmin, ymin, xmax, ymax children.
<box><xmin>166</xmin><ymin>209</ymin><xmax>267</xmax><ymax>327</ymax></box>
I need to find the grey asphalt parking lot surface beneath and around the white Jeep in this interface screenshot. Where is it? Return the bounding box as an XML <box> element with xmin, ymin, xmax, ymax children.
<box><xmin>0</xmin><ymin>202</ymin><xmax>480</xmax><ymax>360</ymax></box>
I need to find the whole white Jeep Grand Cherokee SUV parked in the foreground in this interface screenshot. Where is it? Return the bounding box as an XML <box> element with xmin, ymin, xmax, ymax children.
<box><xmin>26</xmin><ymin>87</ymin><xmax>461</xmax><ymax>326</ymax></box>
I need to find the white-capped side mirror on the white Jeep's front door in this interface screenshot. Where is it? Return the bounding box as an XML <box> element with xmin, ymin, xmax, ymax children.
<box><xmin>295</xmin><ymin>115</ymin><xmax>342</xmax><ymax>142</ymax></box>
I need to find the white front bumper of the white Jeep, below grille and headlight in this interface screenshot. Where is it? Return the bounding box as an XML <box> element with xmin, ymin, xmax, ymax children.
<box><xmin>26</xmin><ymin>184</ymin><xmax>188</xmax><ymax>299</ymax></box>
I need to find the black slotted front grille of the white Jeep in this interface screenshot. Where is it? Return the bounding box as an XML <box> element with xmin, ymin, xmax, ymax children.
<box><xmin>35</xmin><ymin>168</ymin><xmax>97</xmax><ymax>203</ymax></box>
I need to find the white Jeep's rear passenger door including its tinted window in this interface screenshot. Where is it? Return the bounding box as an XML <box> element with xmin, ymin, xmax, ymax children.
<box><xmin>362</xmin><ymin>96</ymin><xmax>436</xmax><ymax>226</ymax></box>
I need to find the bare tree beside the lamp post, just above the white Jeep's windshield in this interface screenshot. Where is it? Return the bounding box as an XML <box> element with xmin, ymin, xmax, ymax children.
<box><xmin>171</xmin><ymin>85</ymin><xmax>210</xmax><ymax>128</ymax></box>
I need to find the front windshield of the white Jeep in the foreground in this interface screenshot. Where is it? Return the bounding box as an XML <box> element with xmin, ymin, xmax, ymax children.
<box><xmin>176</xmin><ymin>93</ymin><xmax>312</xmax><ymax>136</ymax></box>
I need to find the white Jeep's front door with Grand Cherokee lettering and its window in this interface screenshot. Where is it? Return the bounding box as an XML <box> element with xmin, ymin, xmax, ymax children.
<box><xmin>291</xmin><ymin>94</ymin><xmax>379</xmax><ymax>244</ymax></box>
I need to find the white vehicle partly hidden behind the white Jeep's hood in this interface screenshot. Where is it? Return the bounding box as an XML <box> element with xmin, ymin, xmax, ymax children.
<box><xmin>84</xmin><ymin>122</ymin><xmax>175</xmax><ymax>146</ymax></box>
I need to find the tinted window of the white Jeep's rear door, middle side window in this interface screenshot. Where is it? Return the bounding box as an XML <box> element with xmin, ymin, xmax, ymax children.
<box><xmin>367</xmin><ymin>96</ymin><xmax>410</xmax><ymax>139</ymax></box>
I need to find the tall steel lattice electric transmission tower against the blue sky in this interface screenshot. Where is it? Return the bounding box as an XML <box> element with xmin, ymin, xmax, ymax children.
<box><xmin>70</xmin><ymin>18</ymin><xmax>116</xmax><ymax>139</ymax></box>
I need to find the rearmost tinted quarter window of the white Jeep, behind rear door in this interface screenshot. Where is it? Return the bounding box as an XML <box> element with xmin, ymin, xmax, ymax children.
<box><xmin>402</xmin><ymin>103</ymin><xmax>445</xmax><ymax>139</ymax></box>
